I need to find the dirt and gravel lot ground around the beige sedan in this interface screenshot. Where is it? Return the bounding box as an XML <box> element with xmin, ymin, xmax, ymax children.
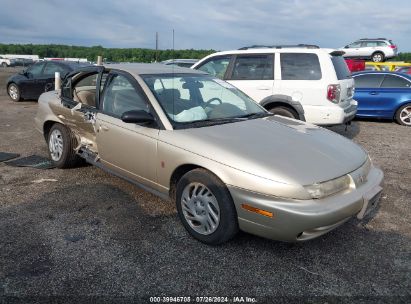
<box><xmin>0</xmin><ymin>69</ymin><xmax>411</xmax><ymax>303</ymax></box>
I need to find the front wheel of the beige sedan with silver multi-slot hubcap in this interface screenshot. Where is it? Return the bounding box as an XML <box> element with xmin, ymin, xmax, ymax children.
<box><xmin>176</xmin><ymin>169</ymin><xmax>238</xmax><ymax>245</ymax></box>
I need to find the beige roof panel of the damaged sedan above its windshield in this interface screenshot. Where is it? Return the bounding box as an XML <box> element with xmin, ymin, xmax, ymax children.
<box><xmin>104</xmin><ymin>63</ymin><xmax>207</xmax><ymax>75</ymax></box>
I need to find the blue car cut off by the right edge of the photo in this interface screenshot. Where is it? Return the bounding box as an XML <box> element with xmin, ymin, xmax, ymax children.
<box><xmin>352</xmin><ymin>71</ymin><xmax>411</xmax><ymax>127</ymax></box>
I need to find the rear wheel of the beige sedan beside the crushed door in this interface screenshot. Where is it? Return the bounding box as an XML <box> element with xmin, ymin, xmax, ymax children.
<box><xmin>47</xmin><ymin>123</ymin><xmax>80</xmax><ymax>169</ymax></box>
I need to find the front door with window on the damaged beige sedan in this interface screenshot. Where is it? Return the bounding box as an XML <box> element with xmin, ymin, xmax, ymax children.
<box><xmin>96</xmin><ymin>71</ymin><xmax>159</xmax><ymax>189</ymax></box>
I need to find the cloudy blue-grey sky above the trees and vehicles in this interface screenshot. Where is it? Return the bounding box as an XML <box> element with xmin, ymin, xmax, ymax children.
<box><xmin>0</xmin><ymin>0</ymin><xmax>411</xmax><ymax>52</ymax></box>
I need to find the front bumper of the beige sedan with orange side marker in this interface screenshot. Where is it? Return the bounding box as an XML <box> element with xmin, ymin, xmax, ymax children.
<box><xmin>228</xmin><ymin>167</ymin><xmax>384</xmax><ymax>242</ymax></box>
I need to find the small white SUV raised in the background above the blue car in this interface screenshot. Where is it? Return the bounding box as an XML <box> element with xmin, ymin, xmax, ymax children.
<box><xmin>340</xmin><ymin>38</ymin><xmax>398</xmax><ymax>62</ymax></box>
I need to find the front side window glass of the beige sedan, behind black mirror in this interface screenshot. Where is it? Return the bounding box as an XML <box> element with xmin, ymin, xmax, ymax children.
<box><xmin>102</xmin><ymin>75</ymin><xmax>150</xmax><ymax>117</ymax></box>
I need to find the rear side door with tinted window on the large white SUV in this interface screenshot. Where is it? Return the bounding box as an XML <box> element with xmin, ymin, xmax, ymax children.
<box><xmin>226</xmin><ymin>54</ymin><xmax>274</xmax><ymax>102</ymax></box>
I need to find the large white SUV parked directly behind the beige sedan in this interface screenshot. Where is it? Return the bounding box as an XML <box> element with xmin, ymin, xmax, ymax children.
<box><xmin>192</xmin><ymin>45</ymin><xmax>357</xmax><ymax>125</ymax></box>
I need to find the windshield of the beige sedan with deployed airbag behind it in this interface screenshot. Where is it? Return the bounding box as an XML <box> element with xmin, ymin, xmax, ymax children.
<box><xmin>142</xmin><ymin>74</ymin><xmax>271</xmax><ymax>128</ymax></box>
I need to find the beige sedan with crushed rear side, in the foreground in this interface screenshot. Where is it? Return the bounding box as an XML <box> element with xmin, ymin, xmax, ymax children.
<box><xmin>35</xmin><ymin>64</ymin><xmax>383</xmax><ymax>244</ymax></box>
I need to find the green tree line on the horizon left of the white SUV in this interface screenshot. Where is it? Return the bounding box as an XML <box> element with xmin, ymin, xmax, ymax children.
<box><xmin>0</xmin><ymin>44</ymin><xmax>215</xmax><ymax>62</ymax></box>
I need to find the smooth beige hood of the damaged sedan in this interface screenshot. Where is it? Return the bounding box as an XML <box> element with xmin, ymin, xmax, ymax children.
<box><xmin>160</xmin><ymin>116</ymin><xmax>367</xmax><ymax>185</ymax></box>
